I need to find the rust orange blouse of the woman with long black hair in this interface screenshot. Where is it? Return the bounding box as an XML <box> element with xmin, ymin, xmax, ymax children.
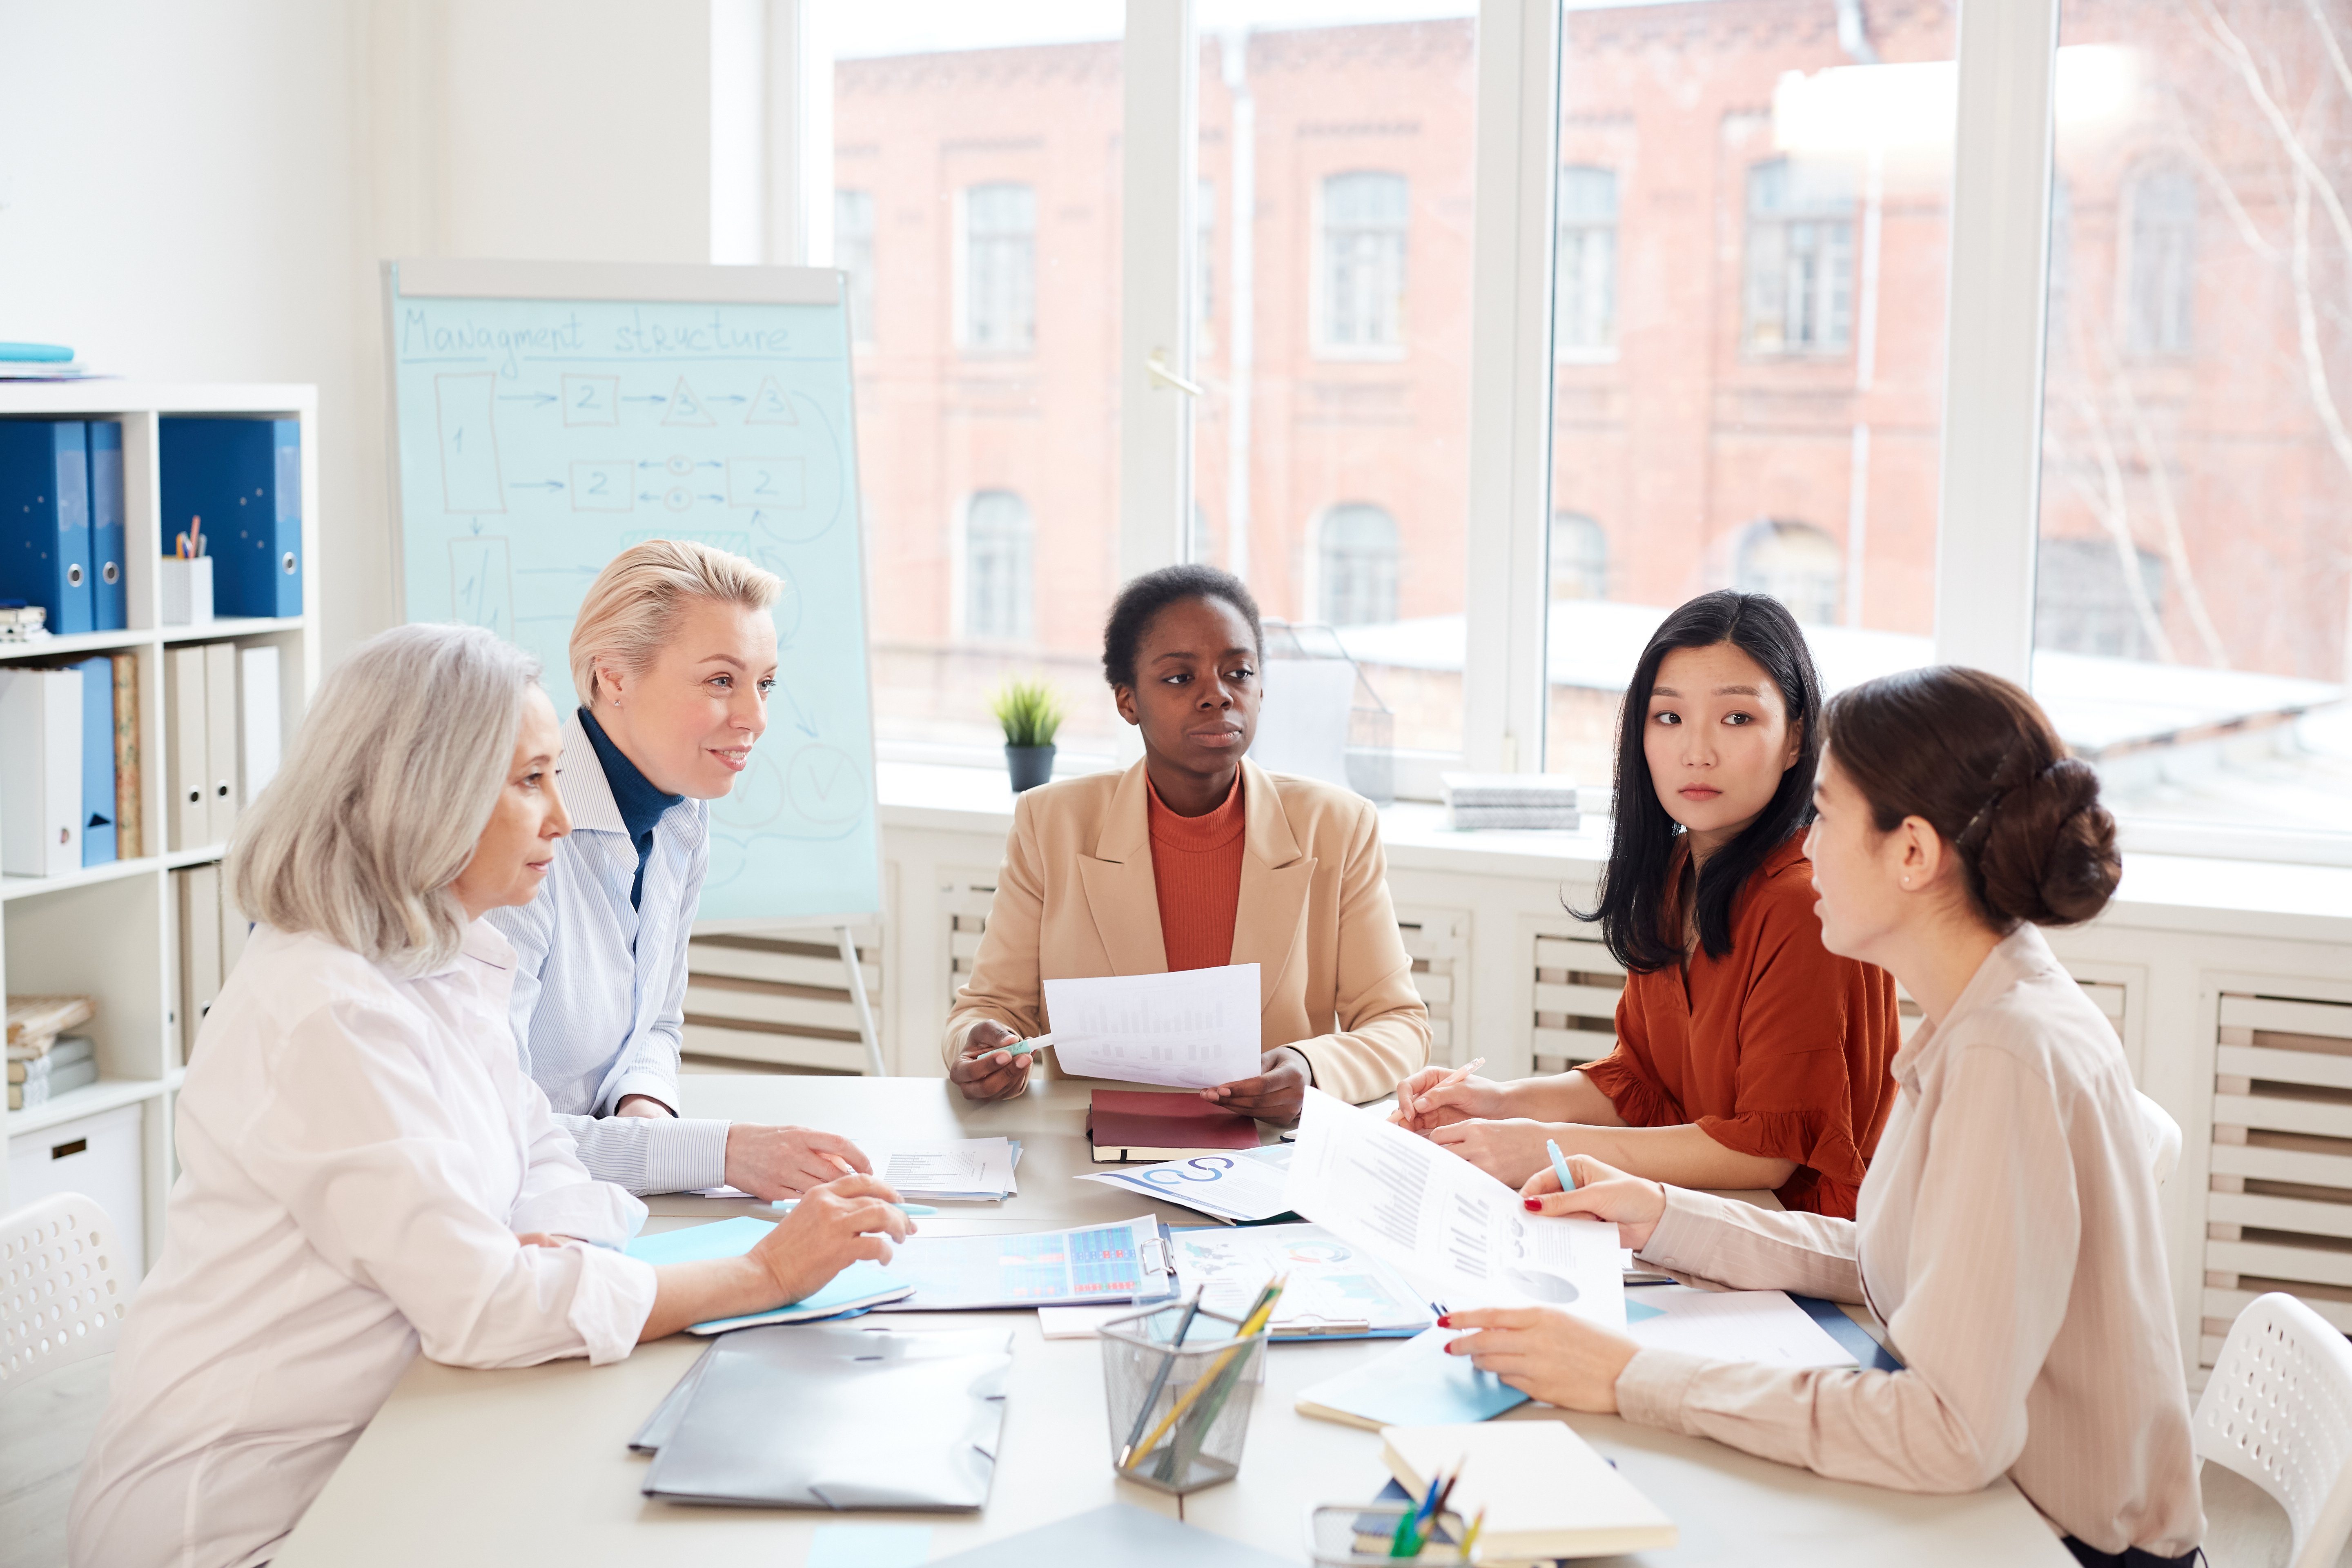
<box><xmin>1583</xmin><ymin>835</ymin><xmax>1903</xmax><ymax>1220</ymax></box>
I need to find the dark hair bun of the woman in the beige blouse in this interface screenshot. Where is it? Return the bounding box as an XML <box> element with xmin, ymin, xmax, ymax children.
<box><xmin>1978</xmin><ymin>757</ymin><xmax>2124</xmax><ymax>926</ymax></box>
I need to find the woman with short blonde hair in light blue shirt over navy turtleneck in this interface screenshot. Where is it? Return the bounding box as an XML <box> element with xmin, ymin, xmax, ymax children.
<box><xmin>492</xmin><ymin>538</ymin><xmax>873</xmax><ymax>1199</ymax></box>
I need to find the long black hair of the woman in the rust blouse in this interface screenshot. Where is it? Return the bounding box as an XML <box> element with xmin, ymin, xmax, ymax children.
<box><xmin>1571</xmin><ymin>588</ymin><xmax>1820</xmax><ymax>971</ymax></box>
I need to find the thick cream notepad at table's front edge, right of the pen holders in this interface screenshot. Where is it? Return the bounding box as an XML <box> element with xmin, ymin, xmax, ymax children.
<box><xmin>1381</xmin><ymin>1420</ymin><xmax>1679</xmax><ymax>1561</ymax></box>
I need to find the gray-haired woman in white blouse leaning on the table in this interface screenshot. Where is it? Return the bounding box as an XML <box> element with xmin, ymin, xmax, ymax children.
<box><xmin>68</xmin><ymin>625</ymin><xmax>910</xmax><ymax>1568</ymax></box>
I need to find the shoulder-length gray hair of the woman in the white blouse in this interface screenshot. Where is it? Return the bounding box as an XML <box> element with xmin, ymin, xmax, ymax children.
<box><xmin>228</xmin><ymin>625</ymin><xmax>539</xmax><ymax>976</ymax></box>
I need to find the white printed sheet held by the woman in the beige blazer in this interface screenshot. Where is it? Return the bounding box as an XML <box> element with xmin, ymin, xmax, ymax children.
<box><xmin>1044</xmin><ymin>964</ymin><xmax>1261</xmax><ymax>1089</ymax></box>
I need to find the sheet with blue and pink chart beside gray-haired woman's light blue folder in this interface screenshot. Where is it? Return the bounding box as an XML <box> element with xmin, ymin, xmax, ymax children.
<box><xmin>870</xmin><ymin>1215</ymin><xmax>1176</xmax><ymax>1312</ymax></box>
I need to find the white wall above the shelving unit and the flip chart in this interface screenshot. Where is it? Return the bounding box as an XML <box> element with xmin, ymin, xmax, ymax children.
<box><xmin>0</xmin><ymin>0</ymin><xmax>710</xmax><ymax>661</ymax></box>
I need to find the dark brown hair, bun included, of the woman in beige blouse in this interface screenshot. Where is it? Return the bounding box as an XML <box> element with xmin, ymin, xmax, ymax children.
<box><xmin>1823</xmin><ymin>665</ymin><xmax>2124</xmax><ymax>933</ymax></box>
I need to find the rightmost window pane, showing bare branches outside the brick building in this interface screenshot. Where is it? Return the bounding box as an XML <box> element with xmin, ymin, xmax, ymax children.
<box><xmin>2032</xmin><ymin>0</ymin><xmax>2352</xmax><ymax>858</ymax></box>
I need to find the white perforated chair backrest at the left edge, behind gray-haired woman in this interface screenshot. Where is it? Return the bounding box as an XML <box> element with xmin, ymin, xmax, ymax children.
<box><xmin>0</xmin><ymin>1192</ymin><xmax>136</xmax><ymax>1396</ymax></box>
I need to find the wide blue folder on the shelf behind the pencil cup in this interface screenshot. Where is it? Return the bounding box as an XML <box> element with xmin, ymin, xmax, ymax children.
<box><xmin>160</xmin><ymin>416</ymin><xmax>303</xmax><ymax>616</ymax></box>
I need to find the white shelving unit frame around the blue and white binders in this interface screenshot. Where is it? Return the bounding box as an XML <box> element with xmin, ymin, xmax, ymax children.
<box><xmin>0</xmin><ymin>381</ymin><xmax>320</xmax><ymax>1263</ymax></box>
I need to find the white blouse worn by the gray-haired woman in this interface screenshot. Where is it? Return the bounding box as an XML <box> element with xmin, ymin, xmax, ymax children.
<box><xmin>68</xmin><ymin>922</ymin><xmax>654</xmax><ymax>1568</ymax></box>
